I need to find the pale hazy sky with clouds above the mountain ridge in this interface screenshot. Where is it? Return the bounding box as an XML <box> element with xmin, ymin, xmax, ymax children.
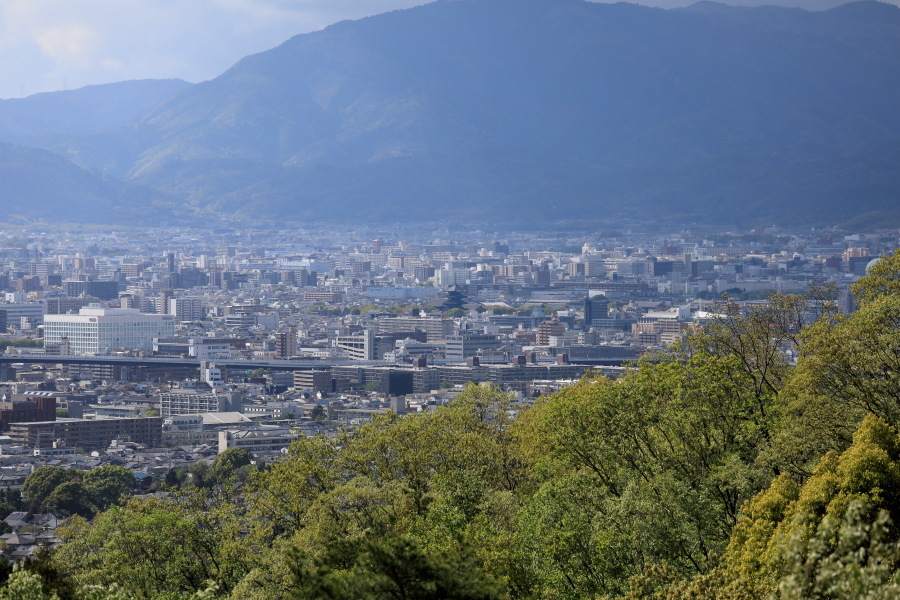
<box><xmin>0</xmin><ymin>0</ymin><xmax>900</xmax><ymax>98</ymax></box>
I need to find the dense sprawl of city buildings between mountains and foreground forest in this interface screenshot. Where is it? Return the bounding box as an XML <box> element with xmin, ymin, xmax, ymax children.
<box><xmin>0</xmin><ymin>220</ymin><xmax>888</xmax><ymax>516</ymax></box>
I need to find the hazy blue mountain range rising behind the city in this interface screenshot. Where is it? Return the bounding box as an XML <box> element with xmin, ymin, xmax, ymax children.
<box><xmin>0</xmin><ymin>0</ymin><xmax>900</xmax><ymax>228</ymax></box>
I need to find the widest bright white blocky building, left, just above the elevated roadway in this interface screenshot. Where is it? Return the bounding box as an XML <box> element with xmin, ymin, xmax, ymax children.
<box><xmin>44</xmin><ymin>307</ymin><xmax>175</xmax><ymax>354</ymax></box>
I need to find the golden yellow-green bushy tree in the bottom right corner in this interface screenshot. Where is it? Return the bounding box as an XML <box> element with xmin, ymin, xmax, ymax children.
<box><xmin>644</xmin><ymin>415</ymin><xmax>900</xmax><ymax>600</ymax></box>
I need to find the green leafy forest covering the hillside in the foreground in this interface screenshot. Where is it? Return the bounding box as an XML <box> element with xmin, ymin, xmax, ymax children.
<box><xmin>0</xmin><ymin>250</ymin><xmax>900</xmax><ymax>600</ymax></box>
